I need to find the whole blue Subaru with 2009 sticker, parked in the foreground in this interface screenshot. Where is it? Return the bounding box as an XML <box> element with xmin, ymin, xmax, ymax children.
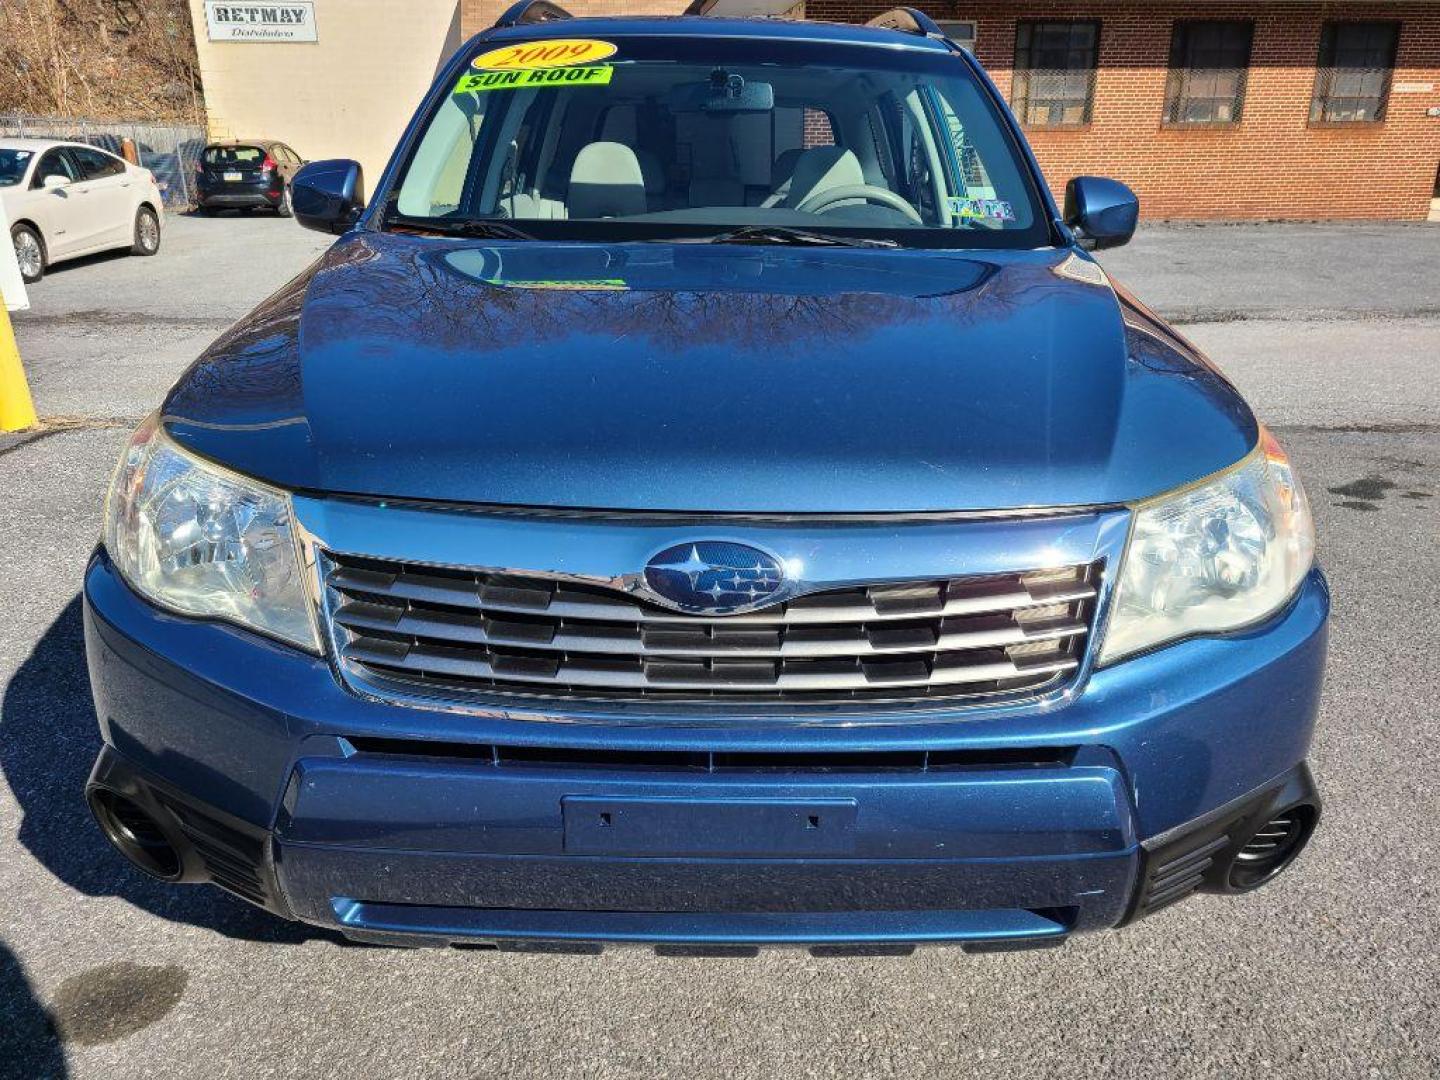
<box><xmin>85</xmin><ymin>0</ymin><xmax>1329</xmax><ymax>953</ymax></box>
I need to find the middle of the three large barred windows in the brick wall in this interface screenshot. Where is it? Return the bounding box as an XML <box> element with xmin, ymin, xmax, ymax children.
<box><xmin>1165</xmin><ymin>22</ymin><xmax>1254</xmax><ymax>124</ymax></box>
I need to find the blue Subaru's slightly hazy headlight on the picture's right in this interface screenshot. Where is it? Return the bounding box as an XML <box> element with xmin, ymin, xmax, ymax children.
<box><xmin>1099</xmin><ymin>429</ymin><xmax>1315</xmax><ymax>665</ymax></box>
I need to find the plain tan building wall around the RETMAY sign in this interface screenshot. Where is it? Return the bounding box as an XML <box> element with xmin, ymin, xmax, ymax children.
<box><xmin>190</xmin><ymin>0</ymin><xmax>461</xmax><ymax>187</ymax></box>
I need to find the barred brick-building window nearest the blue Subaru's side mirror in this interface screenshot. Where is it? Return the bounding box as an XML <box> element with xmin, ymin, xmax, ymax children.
<box><xmin>1011</xmin><ymin>22</ymin><xmax>1100</xmax><ymax>127</ymax></box>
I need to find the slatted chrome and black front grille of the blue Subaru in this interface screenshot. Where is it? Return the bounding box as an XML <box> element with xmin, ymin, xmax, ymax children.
<box><xmin>324</xmin><ymin>554</ymin><xmax>1097</xmax><ymax>703</ymax></box>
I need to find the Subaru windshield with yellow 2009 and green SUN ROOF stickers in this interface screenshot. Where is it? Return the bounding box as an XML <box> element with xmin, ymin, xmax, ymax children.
<box><xmin>390</xmin><ymin>35</ymin><xmax>1048</xmax><ymax>248</ymax></box>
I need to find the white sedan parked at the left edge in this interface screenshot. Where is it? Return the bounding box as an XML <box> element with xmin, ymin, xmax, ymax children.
<box><xmin>0</xmin><ymin>138</ymin><xmax>163</xmax><ymax>282</ymax></box>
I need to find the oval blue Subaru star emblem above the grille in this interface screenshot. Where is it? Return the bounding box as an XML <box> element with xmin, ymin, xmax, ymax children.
<box><xmin>645</xmin><ymin>540</ymin><xmax>789</xmax><ymax>615</ymax></box>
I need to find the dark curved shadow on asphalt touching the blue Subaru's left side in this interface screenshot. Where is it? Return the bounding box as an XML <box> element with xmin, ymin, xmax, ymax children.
<box><xmin>0</xmin><ymin>596</ymin><xmax>344</xmax><ymax>944</ymax></box>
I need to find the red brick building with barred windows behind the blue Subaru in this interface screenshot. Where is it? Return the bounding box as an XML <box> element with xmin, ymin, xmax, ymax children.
<box><xmin>459</xmin><ymin>0</ymin><xmax>1440</xmax><ymax>220</ymax></box>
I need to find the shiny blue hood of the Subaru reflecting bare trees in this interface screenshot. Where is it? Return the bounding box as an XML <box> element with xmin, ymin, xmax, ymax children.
<box><xmin>164</xmin><ymin>233</ymin><xmax>1256</xmax><ymax>514</ymax></box>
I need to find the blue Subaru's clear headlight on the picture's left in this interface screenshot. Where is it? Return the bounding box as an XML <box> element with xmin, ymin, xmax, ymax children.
<box><xmin>105</xmin><ymin>416</ymin><xmax>320</xmax><ymax>652</ymax></box>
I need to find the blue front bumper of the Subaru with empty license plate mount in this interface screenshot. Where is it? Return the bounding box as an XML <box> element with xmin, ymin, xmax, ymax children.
<box><xmin>85</xmin><ymin>554</ymin><xmax>1329</xmax><ymax>949</ymax></box>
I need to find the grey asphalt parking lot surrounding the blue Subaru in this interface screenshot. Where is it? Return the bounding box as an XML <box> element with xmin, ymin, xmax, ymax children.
<box><xmin>0</xmin><ymin>217</ymin><xmax>1440</xmax><ymax>1080</ymax></box>
